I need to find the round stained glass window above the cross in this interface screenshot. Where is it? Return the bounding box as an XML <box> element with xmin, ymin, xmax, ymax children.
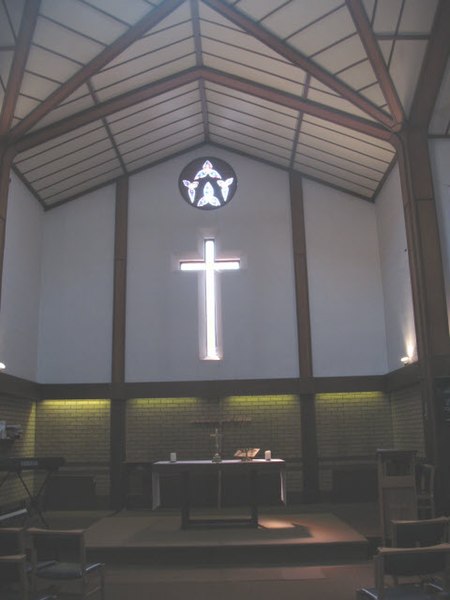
<box><xmin>178</xmin><ymin>157</ymin><xmax>237</xmax><ymax>210</ymax></box>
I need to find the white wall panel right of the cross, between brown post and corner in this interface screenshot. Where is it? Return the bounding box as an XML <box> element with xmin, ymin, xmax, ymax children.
<box><xmin>303</xmin><ymin>180</ymin><xmax>387</xmax><ymax>377</ymax></box>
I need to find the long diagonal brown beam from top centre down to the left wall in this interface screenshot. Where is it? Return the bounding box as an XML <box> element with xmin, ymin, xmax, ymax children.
<box><xmin>7</xmin><ymin>0</ymin><xmax>185</xmax><ymax>141</ymax></box>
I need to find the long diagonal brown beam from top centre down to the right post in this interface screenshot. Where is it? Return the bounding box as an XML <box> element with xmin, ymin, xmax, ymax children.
<box><xmin>203</xmin><ymin>0</ymin><xmax>395</xmax><ymax>128</ymax></box>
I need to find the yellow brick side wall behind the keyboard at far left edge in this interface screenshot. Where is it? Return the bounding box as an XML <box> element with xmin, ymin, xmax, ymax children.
<box><xmin>0</xmin><ymin>398</ymin><xmax>36</xmax><ymax>507</ymax></box>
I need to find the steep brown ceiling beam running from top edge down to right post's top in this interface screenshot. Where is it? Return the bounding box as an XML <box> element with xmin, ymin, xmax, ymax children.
<box><xmin>346</xmin><ymin>0</ymin><xmax>405</xmax><ymax>131</ymax></box>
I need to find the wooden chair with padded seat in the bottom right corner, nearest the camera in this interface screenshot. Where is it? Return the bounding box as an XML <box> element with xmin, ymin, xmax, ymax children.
<box><xmin>356</xmin><ymin>544</ymin><xmax>450</xmax><ymax>600</ymax></box>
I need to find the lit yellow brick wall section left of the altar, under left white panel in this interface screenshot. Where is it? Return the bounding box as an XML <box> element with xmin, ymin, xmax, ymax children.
<box><xmin>36</xmin><ymin>399</ymin><xmax>110</xmax><ymax>496</ymax></box>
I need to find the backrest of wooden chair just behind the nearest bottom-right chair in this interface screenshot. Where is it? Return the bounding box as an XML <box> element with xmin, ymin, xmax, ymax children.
<box><xmin>392</xmin><ymin>517</ymin><xmax>449</xmax><ymax>548</ymax></box>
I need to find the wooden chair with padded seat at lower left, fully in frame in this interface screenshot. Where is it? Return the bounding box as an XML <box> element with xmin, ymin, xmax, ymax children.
<box><xmin>28</xmin><ymin>528</ymin><xmax>105</xmax><ymax>600</ymax></box>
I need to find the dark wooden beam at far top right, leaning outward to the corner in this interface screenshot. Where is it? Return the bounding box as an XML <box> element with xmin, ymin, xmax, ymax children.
<box><xmin>409</xmin><ymin>0</ymin><xmax>450</xmax><ymax>130</ymax></box>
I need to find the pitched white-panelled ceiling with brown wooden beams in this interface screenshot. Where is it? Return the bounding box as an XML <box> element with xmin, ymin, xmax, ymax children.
<box><xmin>0</xmin><ymin>0</ymin><xmax>450</xmax><ymax>208</ymax></box>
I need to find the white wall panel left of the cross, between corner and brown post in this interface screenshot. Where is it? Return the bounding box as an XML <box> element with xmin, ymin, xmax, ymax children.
<box><xmin>38</xmin><ymin>185</ymin><xmax>115</xmax><ymax>383</ymax></box>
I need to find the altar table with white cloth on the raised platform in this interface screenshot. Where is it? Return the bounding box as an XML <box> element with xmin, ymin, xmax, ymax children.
<box><xmin>152</xmin><ymin>458</ymin><xmax>286</xmax><ymax>529</ymax></box>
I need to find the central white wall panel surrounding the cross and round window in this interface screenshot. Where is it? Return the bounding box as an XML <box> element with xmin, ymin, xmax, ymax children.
<box><xmin>126</xmin><ymin>148</ymin><xmax>298</xmax><ymax>381</ymax></box>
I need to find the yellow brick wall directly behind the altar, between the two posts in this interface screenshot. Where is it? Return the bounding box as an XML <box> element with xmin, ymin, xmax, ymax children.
<box><xmin>126</xmin><ymin>395</ymin><xmax>301</xmax><ymax>489</ymax></box>
